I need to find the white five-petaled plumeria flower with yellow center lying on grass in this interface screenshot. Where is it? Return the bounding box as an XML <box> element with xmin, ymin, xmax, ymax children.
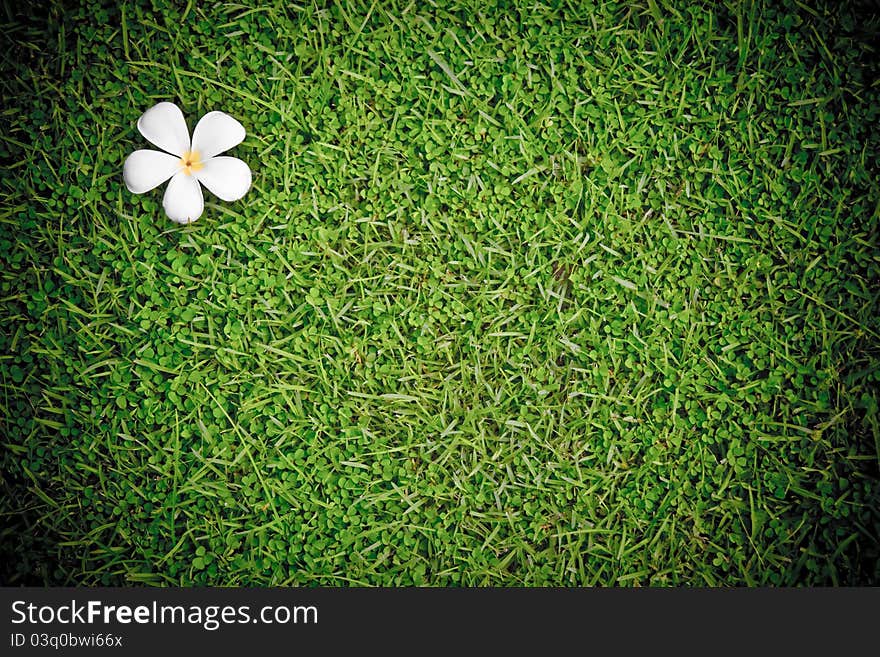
<box><xmin>122</xmin><ymin>103</ymin><xmax>251</xmax><ymax>224</ymax></box>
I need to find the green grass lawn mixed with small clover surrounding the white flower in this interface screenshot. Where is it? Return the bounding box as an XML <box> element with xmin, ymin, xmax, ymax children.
<box><xmin>0</xmin><ymin>0</ymin><xmax>880</xmax><ymax>586</ymax></box>
